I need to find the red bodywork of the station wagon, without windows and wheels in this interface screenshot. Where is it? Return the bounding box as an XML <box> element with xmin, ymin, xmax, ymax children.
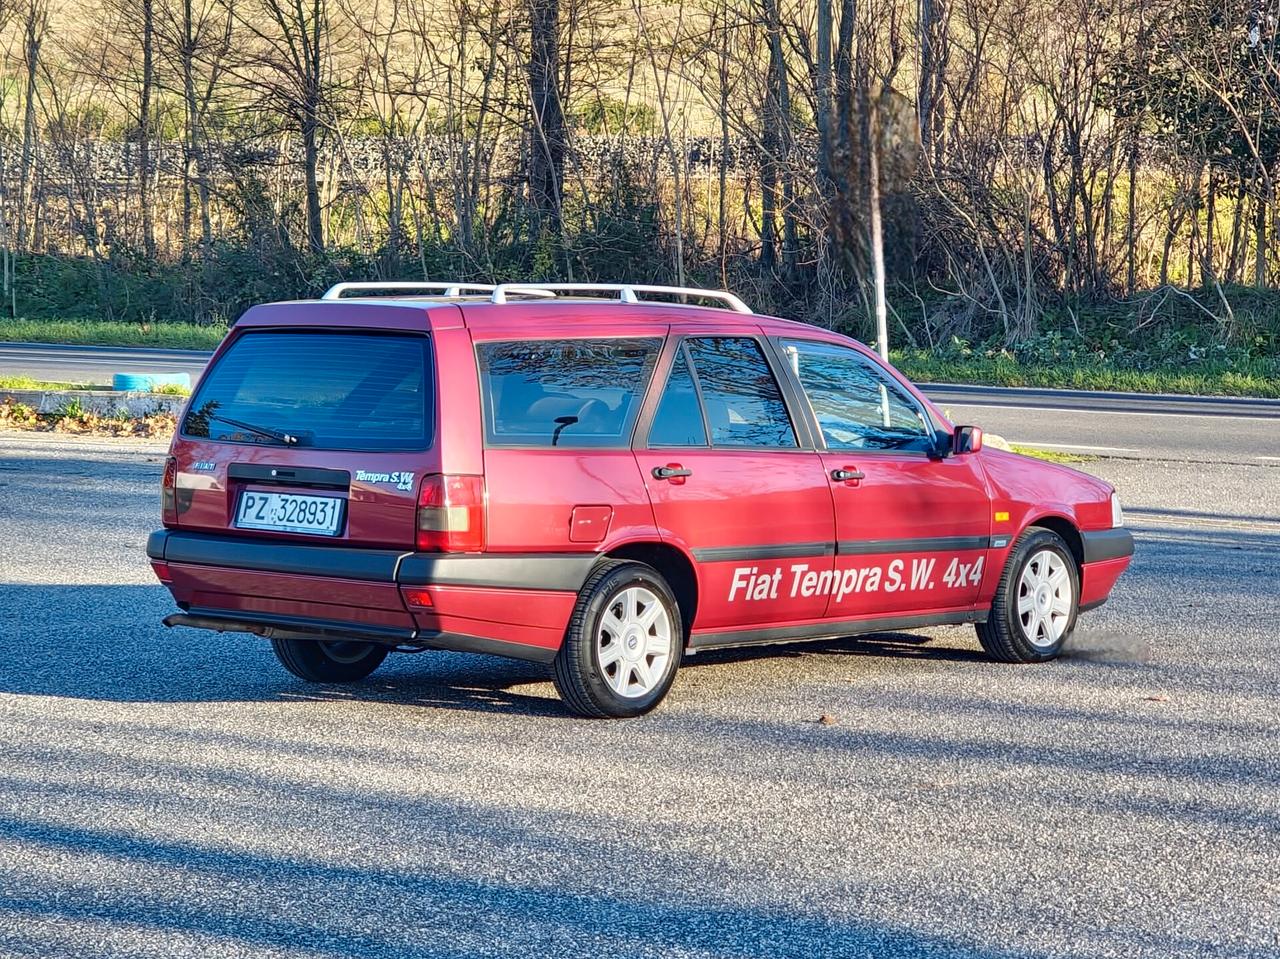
<box><xmin>148</xmin><ymin>298</ymin><xmax>1132</xmax><ymax>661</ymax></box>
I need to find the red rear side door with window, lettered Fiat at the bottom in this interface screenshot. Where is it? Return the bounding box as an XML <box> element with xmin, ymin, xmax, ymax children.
<box><xmin>636</xmin><ymin>330</ymin><xmax>835</xmax><ymax>630</ymax></box>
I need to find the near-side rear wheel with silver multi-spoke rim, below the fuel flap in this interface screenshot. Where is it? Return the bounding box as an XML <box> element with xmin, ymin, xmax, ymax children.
<box><xmin>552</xmin><ymin>561</ymin><xmax>685</xmax><ymax>718</ymax></box>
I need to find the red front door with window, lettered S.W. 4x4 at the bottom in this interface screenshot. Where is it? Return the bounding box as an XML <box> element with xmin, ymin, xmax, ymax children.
<box><xmin>778</xmin><ymin>339</ymin><xmax>992</xmax><ymax>618</ymax></box>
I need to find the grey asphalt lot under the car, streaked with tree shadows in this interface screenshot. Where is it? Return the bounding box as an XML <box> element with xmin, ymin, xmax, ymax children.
<box><xmin>0</xmin><ymin>434</ymin><xmax>1280</xmax><ymax>959</ymax></box>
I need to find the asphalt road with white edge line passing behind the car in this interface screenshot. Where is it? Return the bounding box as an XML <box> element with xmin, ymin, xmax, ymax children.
<box><xmin>0</xmin><ymin>343</ymin><xmax>1280</xmax><ymax>465</ymax></box>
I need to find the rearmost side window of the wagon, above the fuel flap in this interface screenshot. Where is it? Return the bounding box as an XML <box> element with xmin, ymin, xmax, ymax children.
<box><xmin>476</xmin><ymin>339</ymin><xmax>662</xmax><ymax>447</ymax></box>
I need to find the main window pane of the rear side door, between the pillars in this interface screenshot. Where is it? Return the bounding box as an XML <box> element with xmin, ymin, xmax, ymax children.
<box><xmin>686</xmin><ymin>337</ymin><xmax>799</xmax><ymax>449</ymax></box>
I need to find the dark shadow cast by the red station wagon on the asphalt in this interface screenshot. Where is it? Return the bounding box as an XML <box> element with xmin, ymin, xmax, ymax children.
<box><xmin>0</xmin><ymin>584</ymin><xmax>998</xmax><ymax>718</ymax></box>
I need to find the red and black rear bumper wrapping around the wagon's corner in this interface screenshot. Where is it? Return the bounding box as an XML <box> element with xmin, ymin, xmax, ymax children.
<box><xmin>147</xmin><ymin>530</ymin><xmax>596</xmax><ymax>662</ymax></box>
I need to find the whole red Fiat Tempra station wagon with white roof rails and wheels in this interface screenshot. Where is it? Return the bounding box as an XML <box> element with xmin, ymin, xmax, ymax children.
<box><xmin>147</xmin><ymin>283</ymin><xmax>1133</xmax><ymax>717</ymax></box>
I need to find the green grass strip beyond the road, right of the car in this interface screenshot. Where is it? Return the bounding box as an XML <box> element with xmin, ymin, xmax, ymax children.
<box><xmin>890</xmin><ymin>351</ymin><xmax>1280</xmax><ymax>398</ymax></box>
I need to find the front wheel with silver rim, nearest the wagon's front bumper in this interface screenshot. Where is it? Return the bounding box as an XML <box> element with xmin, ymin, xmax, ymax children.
<box><xmin>977</xmin><ymin>526</ymin><xmax>1080</xmax><ymax>663</ymax></box>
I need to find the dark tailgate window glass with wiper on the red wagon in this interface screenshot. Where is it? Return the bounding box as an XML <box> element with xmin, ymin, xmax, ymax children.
<box><xmin>183</xmin><ymin>330</ymin><xmax>434</xmax><ymax>451</ymax></box>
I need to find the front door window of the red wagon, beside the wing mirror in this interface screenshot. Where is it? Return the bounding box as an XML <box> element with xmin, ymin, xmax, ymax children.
<box><xmin>782</xmin><ymin>339</ymin><xmax>933</xmax><ymax>452</ymax></box>
